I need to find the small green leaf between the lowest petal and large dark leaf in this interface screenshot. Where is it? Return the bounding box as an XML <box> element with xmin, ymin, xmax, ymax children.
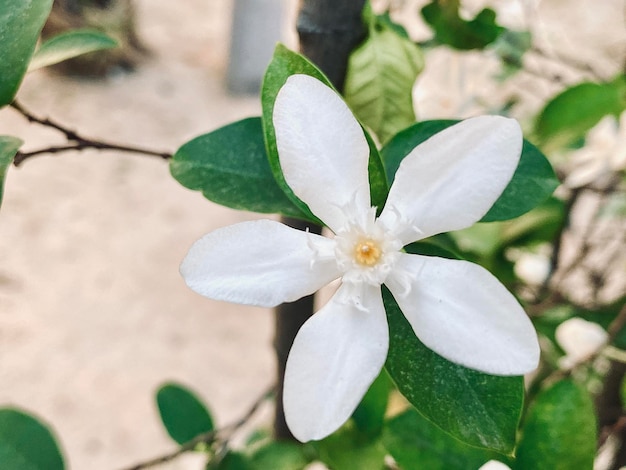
<box><xmin>352</xmin><ymin>369</ymin><xmax>393</xmax><ymax>436</ymax></box>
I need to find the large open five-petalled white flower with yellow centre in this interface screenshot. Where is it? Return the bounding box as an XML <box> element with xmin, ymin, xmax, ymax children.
<box><xmin>181</xmin><ymin>75</ymin><xmax>539</xmax><ymax>441</ymax></box>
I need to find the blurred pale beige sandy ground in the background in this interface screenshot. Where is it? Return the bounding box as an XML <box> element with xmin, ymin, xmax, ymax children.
<box><xmin>0</xmin><ymin>0</ymin><xmax>623</xmax><ymax>470</ymax></box>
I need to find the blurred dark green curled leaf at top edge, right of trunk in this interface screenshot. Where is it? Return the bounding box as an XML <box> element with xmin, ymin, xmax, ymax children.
<box><xmin>422</xmin><ymin>0</ymin><xmax>504</xmax><ymax>50</ymax></box>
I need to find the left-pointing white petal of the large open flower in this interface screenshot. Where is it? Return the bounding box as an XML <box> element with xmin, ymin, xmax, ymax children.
<box><xmin>180</xmin><ymin>220</ymin><xmax>339</xmax><ymax>307</ymax></box>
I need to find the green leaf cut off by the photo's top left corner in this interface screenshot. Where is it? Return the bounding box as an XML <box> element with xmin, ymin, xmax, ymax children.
<box><xmin>0</xmin><ymin>0</ymin><xmax>52</xmax><ymax>108</ymax></box>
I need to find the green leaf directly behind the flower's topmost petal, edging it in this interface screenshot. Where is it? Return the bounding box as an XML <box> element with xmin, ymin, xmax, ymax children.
<box><xmin>261</xmin><ymin>44</ymin><xmax>388</xmax><ymax>220</ymax></box>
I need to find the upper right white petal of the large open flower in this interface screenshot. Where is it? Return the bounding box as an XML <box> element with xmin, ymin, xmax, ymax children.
<box><xmin>381</xmin><ymin>116</ymin><xmax>523</xmax><ymax>243</ymax></box>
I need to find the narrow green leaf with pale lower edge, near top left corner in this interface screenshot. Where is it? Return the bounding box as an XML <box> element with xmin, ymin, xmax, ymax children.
<box><xmin>28</xmin><ymin>29</ymin><xmax>118</xmax><ymax>72</ymax></box>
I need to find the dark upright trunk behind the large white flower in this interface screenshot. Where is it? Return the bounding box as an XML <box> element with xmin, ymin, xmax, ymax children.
<box><xmin>274</xmin><ymin>0</ymin><xmax>366</xmax><ymax>439</ymax></box>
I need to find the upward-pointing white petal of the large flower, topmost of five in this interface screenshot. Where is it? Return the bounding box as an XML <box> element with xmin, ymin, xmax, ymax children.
<box><xmin>273</xmin><ymin>75</ymin><xmax>370</xmax><ymax>232</ymax></box>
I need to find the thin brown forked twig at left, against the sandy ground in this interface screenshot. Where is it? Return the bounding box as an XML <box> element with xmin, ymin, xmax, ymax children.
<box><xmin>11</xmin><ymin>101</ymin><xmax>172</xmax><ymax>166</ymax></box>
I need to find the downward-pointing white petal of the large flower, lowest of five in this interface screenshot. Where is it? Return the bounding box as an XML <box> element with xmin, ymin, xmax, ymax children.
<box><xmin>283</xmin><ymin>284</ymin><xmax>389</xmax><ymax>442</ymax></box>
